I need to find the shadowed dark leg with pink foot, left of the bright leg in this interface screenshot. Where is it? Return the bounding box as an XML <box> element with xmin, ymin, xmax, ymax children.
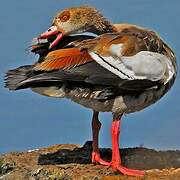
<box><xmin>92</xmin><ymin>111</ymin><xmax>110</xmax><ymax>166</ymax></box>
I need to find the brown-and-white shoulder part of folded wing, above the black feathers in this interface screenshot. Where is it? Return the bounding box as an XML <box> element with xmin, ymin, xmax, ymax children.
<box><xmin>75</xmin><ymin>27</ymin><xmax>176</xmax><ymax>88</ymax></box>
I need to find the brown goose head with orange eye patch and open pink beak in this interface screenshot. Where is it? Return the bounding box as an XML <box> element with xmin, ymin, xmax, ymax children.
<box><xmin>38</xmin><ymin>6</ymin><xmax>115</xmax><ymax>49</ymax></box>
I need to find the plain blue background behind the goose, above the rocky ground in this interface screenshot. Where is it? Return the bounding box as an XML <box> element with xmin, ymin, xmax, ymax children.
<box><xmin>0</xmin><ymin>0</ymin><xmax>180</xmax><ymax>153</ymax></box>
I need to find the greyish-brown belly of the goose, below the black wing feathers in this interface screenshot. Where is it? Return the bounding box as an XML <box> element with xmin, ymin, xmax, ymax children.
<box><xmin>32</xmin><ymin>76</ymin><xmax>174</xmax><ymax>115</ymax></box>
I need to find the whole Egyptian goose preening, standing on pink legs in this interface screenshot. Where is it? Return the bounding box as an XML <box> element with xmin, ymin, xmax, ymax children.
<box><xmin>5</xmin><ymin>6</ymin><xmax>177</xmax><ymax>176</ymax></box>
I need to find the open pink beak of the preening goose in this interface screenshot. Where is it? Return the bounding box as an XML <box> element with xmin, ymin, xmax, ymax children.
<box><xmin>38</xmin><ymin>26</ymin><xmax>63</xmax><ymax>49</ymax></box>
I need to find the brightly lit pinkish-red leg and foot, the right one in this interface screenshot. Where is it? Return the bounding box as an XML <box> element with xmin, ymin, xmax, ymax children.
<box><xmin>111</xmin><ymin>119</ymin><xmax>144</xmax><ymax>176</ymax></box>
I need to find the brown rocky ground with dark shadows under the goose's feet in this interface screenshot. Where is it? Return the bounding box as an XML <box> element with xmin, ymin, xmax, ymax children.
<box><xmin>0</xmin><ymin>141</ymin><xmax>180</xmax><ymax>180</ymax></box>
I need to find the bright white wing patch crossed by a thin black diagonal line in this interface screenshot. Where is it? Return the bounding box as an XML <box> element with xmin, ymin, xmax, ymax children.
<box><xmin>89</xmin><ymin>49</ymin><xmax>175</xmax><ymax>81</ymax></box>
